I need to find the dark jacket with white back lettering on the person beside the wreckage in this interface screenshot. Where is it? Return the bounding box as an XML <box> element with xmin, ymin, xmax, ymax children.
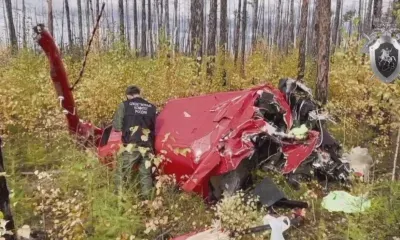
<box><xmin>113</xmin><ymin>97</ymin><xmax>156</xmax><ymax>149</ymax></box>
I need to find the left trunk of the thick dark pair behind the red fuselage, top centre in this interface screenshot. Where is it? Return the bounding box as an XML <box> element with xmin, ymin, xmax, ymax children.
<box><xmin>190</xmin><ymin>0</ymin><xmax>204</xmax><ymax>60</ymax></box>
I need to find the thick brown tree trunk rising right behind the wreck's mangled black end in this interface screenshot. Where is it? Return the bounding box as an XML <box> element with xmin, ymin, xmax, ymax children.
<box><xmin>315</xmin><ymin>0</ymin><xmax>331</xmax><ymax>104</ymax></box>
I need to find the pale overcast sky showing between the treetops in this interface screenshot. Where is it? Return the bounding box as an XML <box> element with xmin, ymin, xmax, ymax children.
<box><xmin>0</xmin><ymin>0</ymin><xmax>390</xmax><ymax>47</ymax></box>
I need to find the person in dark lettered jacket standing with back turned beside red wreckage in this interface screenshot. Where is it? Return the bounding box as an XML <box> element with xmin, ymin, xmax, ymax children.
<box><xmin>113</xmin><ymin>86</ymin><xmax>156</xmax><ymax>198</ymax></box>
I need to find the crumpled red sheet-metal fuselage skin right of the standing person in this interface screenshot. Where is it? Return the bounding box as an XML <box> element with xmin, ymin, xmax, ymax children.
<box><xmin>155</xmin><ymin>85</ymin><xmax>293</xmax><ymax>196</ymax></box>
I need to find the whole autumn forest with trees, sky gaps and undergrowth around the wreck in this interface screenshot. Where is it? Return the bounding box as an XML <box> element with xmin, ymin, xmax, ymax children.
<box><xmin>0</xmin><ymin>0</ymin><xmax>400</xmax><ymax>240</ymax></box>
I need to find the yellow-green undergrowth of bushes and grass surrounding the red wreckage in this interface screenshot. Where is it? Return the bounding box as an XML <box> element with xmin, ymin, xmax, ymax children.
<box><xmin>0</xmin><ymin>40</ymin><xmax>400</xmax><ymax>239</ymax></box>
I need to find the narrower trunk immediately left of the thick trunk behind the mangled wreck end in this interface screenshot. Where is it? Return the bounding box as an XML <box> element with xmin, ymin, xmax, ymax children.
<box><xmin>297</xmin><ymin>0</ymin><xmax>308</xmax><ymax>80</ymax></box>
